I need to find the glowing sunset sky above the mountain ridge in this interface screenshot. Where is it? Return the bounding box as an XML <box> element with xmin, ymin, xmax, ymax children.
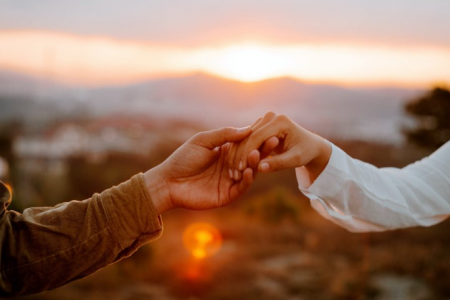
<box><xmin>0</xmin><ymin>0</ymin><xmax>450</xmax><ymax>87</ymax></box>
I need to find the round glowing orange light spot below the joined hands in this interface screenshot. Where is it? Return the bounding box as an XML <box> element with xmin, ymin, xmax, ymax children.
<box><xmin>183</xmin><ymin>223</ymin><xmax>222</xmax><ymax>259</ymax></box>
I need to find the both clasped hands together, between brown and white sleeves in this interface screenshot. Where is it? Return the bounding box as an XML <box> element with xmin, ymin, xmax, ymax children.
<box><xmin>144</xmin><ymin>112</ymin><xmax>331</xmax><ymax>213</ymax></box>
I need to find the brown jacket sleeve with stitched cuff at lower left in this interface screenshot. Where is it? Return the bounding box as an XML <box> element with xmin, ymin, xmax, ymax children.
<box><xmin>0</xmin><ymin>174</ymin><xmax>162</xmax><ymax>297</ymax></box>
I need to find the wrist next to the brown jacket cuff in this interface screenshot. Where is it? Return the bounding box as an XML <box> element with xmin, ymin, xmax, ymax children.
<box><xmin>144</xmin><ymin>167</ymin><xmax>174</xmax><ymax>214</ymax></box>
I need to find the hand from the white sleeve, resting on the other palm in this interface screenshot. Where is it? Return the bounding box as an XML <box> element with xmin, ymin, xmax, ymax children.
<box><xmin>227</xmin><ymin>112</ymin><xmax>331</xmax><ymax>181</ymax></box>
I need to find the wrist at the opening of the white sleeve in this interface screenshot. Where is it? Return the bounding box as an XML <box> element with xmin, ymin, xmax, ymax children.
<box><xmin>305</xmin><ymin>135</ymin><xmax>331</xmax><ymax>182</ymax></box>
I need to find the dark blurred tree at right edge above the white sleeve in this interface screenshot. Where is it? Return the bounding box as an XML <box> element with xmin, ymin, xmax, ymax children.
<box><xmin>405</xmin><ymin>87</ymin><xmax>450</xmax><ymax>149</ymax></box>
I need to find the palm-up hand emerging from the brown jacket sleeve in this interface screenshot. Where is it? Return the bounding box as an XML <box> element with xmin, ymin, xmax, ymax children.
<box><xmin>145</xmin><ymin>127</ymin><xmax>274</xmax><ymax>213</ymax></box>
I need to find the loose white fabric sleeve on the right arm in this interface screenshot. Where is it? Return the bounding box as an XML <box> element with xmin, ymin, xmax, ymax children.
<box><xmin>296</xmin><ymin>142</ymin><xmax>450</xmax><ymax>232</ymax></box>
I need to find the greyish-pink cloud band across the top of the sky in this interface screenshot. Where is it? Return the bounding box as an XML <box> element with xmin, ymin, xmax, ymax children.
<box><xmin>0</xmin><ymin>0</ymin><xmax>450</xmax><ymax>46</ymax></box>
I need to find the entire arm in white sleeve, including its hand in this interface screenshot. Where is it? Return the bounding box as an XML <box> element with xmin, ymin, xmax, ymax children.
<box><xmin>228</xmin><ymin>113</ymin><xmax>450</xmax><ymax>232</ymax></box>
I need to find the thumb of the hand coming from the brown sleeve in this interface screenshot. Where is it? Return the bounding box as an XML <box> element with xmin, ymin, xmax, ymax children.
<box><xmin>191</xmin><ymin>127</ymin><xmax>252</xmax><ymax>150</ymax></box>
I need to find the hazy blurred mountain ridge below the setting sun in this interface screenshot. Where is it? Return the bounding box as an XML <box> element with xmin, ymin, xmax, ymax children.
<box><xmin>0</xmin><ymin>69</ymin><xmax>423</xmax><ymax>141</ymax></box>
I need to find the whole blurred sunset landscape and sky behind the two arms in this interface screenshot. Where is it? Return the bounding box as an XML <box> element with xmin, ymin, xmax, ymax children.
<box><xmin>0</xmin><ymin>0</ymin><xmax>450</xmax><ymax>300</ymax></box>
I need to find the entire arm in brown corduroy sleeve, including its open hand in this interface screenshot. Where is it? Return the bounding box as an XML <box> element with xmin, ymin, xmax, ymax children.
<box><xmin>0</xmin><ymin>128</ymin><xmax>270</xmax><ymax>297</ymax></box>
